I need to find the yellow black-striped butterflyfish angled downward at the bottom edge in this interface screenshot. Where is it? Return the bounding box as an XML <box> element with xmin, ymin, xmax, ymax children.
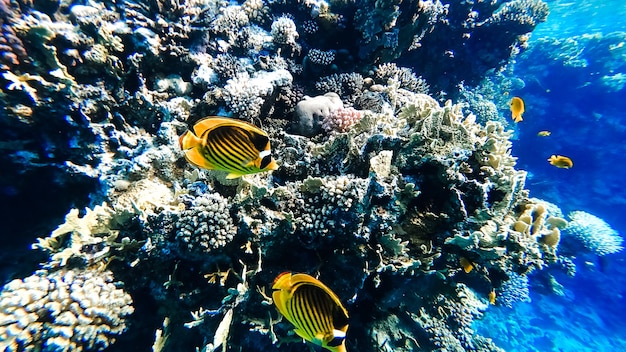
<box><xmin>272</xmin><ymin>272</ymin><xmax>348</xmax><ymax>352</ymax></box>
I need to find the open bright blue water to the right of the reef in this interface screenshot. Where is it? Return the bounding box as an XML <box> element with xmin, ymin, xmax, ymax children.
<box><xmin>475</xmin><ymin>1</ymin><xmax>626</xmax><ymax>351</ymax></box>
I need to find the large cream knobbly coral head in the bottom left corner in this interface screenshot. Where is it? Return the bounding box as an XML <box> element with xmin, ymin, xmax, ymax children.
<box><xmin>0</xmin><ymin>269</ymin><xmax>134</xmax><ymax>351</ymax></box>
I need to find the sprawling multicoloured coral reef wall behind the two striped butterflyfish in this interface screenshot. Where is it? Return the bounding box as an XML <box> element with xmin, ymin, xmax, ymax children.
<box><xmin>0</xmin><ymin>0</ymin><xmax>622</xmax><ymax>351</ymax></box>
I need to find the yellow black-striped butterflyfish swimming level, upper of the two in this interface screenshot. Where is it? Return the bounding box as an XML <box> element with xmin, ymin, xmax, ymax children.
<box><xmin>180</xmin><ymin>116</ymin><xmax>278</xmax><ymax>178</ymax></box>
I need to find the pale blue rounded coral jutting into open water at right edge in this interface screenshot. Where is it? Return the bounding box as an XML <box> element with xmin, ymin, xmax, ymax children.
<box><xmin>564</xmin><ymin>211</ymin><xmax>624</xmax><ymax>256</ymax></box>
